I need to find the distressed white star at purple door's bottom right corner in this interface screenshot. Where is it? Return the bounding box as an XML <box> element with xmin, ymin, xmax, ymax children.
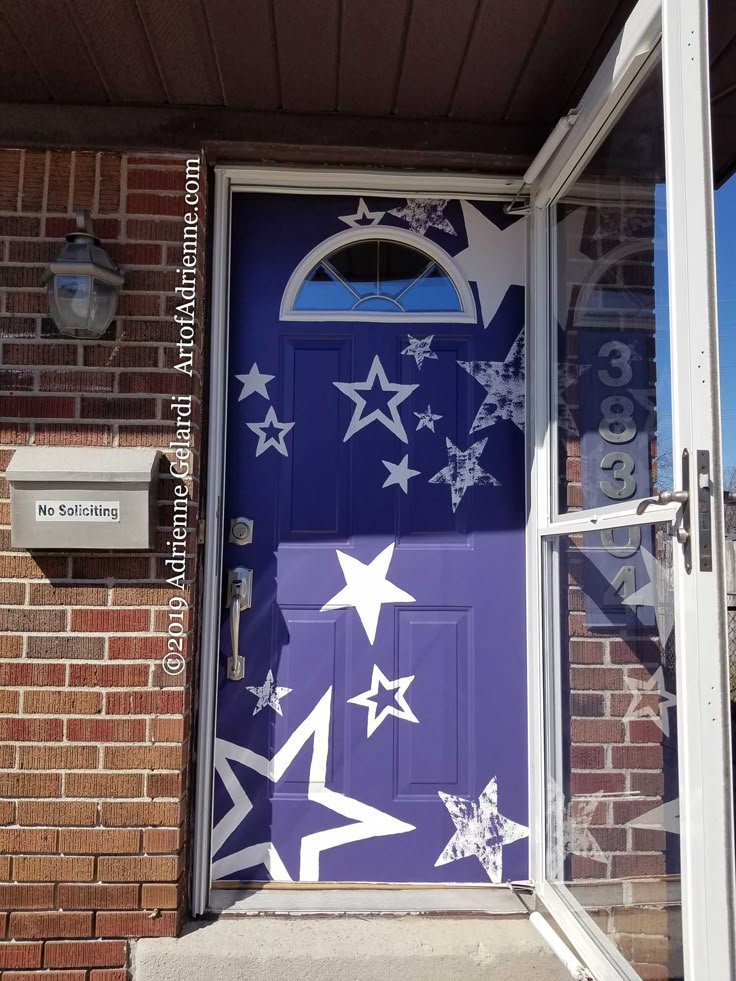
<box><xmin>434</xmin><ymin>777</ymin><xmax>529</xmax><ymax>882</ymax></box>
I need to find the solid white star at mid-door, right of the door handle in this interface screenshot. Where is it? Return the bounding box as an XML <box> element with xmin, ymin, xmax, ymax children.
<box><xmin>320</xmin><ymin>542</ymin><xmax>416</xmax><ymax>644</ymax></box>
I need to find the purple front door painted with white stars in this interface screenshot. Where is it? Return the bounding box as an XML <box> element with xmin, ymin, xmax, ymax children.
<box><xmin>213</xmin><ymin>193</ymin><xmax>528</xmax><ymax>883</ymax></box>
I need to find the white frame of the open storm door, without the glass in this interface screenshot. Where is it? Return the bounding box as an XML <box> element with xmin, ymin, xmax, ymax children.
<box><xmin>527</xmin><ymin>0</ymin><xmax>736</xmax><ymax>981</ymax></box>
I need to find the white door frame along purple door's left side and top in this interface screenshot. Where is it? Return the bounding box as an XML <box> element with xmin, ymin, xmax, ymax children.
<box><xmin>190</xmin><ymin>164</ymin><xmax>532</xmax><ymax>917</ymax></box>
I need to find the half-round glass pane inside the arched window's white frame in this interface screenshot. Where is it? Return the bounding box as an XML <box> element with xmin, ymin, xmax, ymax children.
<box><xmin>294</xmin><ymin>239</ymin><xmax>463</xmax><ymax>314</ymax></box>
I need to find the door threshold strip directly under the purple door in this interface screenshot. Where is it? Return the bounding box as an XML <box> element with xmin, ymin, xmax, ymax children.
<box><xmin>208</xmin><ymin>884</ymin><xmax>527</xmax><ymax>917</ymax></box>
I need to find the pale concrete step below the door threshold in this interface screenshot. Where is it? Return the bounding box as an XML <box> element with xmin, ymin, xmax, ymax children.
<box><xmin>133</xmin><ymin>915</ymin><xmax>570</xmax><ymax>981</ymax></box>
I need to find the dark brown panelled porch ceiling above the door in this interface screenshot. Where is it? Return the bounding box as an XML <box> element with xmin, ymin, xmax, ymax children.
<box><xmin>0</xmin><ymin>0</ymin><xmax>634</xmax><ymax>170</ymax></box>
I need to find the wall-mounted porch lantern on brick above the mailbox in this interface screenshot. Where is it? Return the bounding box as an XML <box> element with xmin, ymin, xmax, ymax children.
<box><xmin>47</xmin><ymin>211</ymin><xmax>123</xmax><ymax>337</ymax></box>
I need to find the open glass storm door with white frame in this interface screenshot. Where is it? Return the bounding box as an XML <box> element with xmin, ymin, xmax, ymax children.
<box><xmin>530</xmin><ymin>0</ymin><xmax>734</xmax><ymax>981</ymax></box>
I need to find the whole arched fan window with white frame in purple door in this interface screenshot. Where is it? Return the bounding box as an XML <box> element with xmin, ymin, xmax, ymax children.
<box><xmin>281</xmin><ymin>228</ymin><xmax>476</xmax><ymax>322</ymax></box>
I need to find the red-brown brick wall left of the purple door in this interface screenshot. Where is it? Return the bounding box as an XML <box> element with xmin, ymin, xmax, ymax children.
<box><xmin>0</xmin><ymin>151</ymin><xmax>205</xmax><ymax>981</ymax></box>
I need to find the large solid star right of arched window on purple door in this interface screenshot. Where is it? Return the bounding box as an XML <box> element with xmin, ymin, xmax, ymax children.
<box><xmin>455</xmin><ymin>201</ymin><xmax>526</xmax><ymax>327</ymax></box>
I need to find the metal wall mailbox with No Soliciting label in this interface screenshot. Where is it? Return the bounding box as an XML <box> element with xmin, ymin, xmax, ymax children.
<box><xmin>7</xmin><ymin>446</ymin><xmax>160</xmax><ymax>551</ymax></box>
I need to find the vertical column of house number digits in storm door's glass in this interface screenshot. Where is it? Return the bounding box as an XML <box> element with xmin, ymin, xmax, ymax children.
<box><xmin>598</xmin><ymin>341</ymin><xmax>641</xmax><ymax>576</ymax></box>
